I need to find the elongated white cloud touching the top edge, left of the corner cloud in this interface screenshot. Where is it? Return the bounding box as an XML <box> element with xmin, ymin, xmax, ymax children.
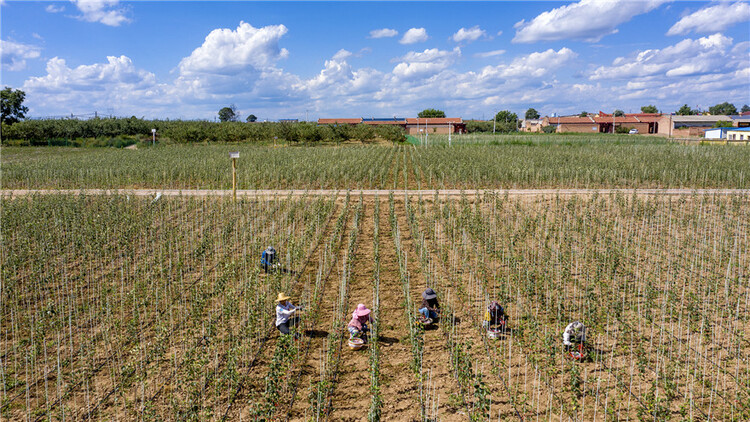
<box><xmin>513</xmin><ymin>0</ymin><xmax>665</xmax><ymax>43</ymax></box>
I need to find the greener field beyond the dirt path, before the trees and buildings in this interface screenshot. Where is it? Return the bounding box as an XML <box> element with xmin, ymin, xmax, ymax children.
<box><xmin>0</xmin><ymin>135</ymin><xmax>750</xmax><ymax>189</ymax></box>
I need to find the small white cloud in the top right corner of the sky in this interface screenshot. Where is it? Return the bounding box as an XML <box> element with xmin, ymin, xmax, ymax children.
<box><xmin>667</xmin><ymin>2</ymin><xmax>750</xmax><ymax>35</ymax></box>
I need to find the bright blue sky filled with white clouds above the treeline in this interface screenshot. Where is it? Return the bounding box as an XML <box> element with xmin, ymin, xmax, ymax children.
<box><xmin>0</xmin><ymin>0</ymin><xmax>750</xmax><ymax>120</ymax></box>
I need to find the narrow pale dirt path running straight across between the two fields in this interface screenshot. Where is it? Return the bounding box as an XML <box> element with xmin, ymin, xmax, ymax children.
<box><xmin>0</xmin><ymin>189</ymin><xmax>750</xmax><ymax>198</ymax></box>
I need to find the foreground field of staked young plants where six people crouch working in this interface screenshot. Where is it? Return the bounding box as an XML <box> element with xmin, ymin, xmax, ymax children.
<box><xmin>0</xmin><ymin>192</ymin><xmax>750</xmax><ymax>421</ymax></box>
